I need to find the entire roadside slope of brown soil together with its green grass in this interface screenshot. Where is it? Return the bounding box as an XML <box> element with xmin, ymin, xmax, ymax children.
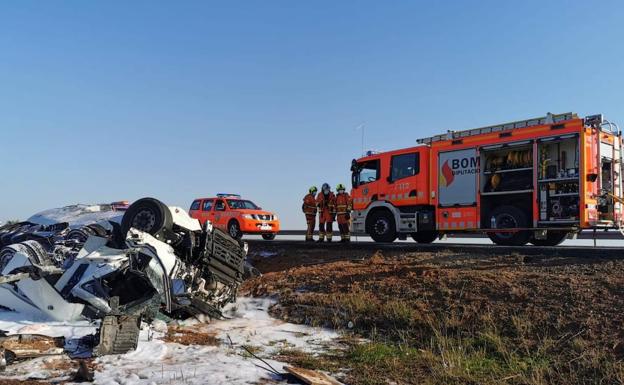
<box><xmin>243</xmin><ymin>244</ymin><xmax>624</xmax><ymax>384</ymax></box>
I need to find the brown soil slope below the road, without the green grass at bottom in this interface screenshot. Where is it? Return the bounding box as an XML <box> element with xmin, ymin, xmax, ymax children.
<box><xmin>243</xmin><ymin>246</ymin><xmax>624</xmax><ymax>383</ymax></box>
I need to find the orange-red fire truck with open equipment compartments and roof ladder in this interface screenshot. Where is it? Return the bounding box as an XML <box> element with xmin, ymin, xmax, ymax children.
<box><xmin>351</xmin><ymin>113</ymin><xmax>623</xmax><ymax>246</ymax></box>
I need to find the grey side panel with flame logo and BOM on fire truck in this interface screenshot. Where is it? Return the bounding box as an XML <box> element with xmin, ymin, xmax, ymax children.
<box><xmin>438</xmin><ymin>148</ymin><xmax>479</xmax><ymax>207</ymax></box>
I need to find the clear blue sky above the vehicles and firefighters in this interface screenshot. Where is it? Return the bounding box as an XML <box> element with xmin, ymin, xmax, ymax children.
<box><xmin>0</xmin><ymin>0</ymin><xmax>624</xmax><ymax>228</ymax></box>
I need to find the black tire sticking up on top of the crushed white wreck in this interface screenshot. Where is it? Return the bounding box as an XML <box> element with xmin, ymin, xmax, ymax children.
<box><xmin>121</xmin><ymin>198</ymin><xmax>173</xmax><ymax>238</ymax></box>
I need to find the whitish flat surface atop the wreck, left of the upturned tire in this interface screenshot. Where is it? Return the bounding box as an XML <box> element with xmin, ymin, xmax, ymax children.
<box><xmin>28</xmin><ymin>204</ymin><xmax>124</xmax><ymax>227</ymax></box>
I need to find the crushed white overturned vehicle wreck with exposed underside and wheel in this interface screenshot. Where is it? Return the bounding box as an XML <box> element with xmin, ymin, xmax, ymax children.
<box><xmin>0</xmin><ymin>198</ymin><xmax>253</xmax><ymax>360</ymax></box>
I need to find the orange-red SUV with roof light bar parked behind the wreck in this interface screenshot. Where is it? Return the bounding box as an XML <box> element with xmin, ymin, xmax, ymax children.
<box><xmin>189</xmin><ymin>194</ymin><xmax>280</xmax><ymax>240</ymax></box>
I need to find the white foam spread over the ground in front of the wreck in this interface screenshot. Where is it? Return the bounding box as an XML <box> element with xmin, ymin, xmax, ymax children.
<box><xmin>0</xmin><ymin>297</ymin><xmax>339</xmax><ymax>385</ymax></box>
